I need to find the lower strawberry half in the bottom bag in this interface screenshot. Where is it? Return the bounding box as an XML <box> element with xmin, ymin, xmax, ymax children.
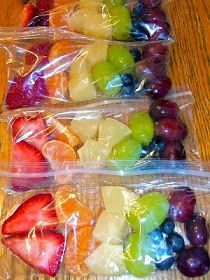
<box><xmin>2</xmin><ymin>231</ymin><xmax>65</xmax><ymax>277</ymax></box>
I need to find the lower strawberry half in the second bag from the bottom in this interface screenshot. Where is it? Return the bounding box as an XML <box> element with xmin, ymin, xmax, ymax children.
<box><xmin>11</xmin><ymin>141</ymin><xmax>48</xmax><ymax>191</ymax></box>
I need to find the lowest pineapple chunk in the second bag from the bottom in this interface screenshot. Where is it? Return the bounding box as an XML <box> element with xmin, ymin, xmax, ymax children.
<box><xmin>78</xmin><ymin>139</ymin><xmax>110</xmax><ymax>161</ymax></box>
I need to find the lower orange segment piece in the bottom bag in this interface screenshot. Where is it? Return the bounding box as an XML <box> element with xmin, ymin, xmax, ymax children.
<box><xmin>64</xmin><ymin>226</ymin><xmax>96</xmax><ymax>276</ymax></box>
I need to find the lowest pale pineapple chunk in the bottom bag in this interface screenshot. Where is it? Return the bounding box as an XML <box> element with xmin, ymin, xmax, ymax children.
<box><xmin>85</xmin><ymin>243</ymin><xmax>126</xmax><ymax>276</ymax></box>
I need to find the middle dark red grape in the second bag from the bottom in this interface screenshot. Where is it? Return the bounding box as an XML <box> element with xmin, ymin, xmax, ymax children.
<box><xmin>155</xmin><ymin>119</ymin><xmax>187</xmax><ymax>142</ymax></box>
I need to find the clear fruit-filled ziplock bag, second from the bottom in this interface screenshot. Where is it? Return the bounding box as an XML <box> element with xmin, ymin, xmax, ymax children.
<box><xmin>1</xmin><ymin>92</ymin><xmax>199</xmax><ymax>191</ymax></box>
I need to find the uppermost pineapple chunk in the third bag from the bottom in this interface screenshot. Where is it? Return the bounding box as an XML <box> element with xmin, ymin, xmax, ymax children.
<box><xmin>84</xmin><ymin>41</ymin><xmax>108</xmax><ymax>66</ymax></box>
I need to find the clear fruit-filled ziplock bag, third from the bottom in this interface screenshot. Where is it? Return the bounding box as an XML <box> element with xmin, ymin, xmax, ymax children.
<box><xmin>1</xmin><ymin>31</ymin><xmax>171</xmax><ymax>109</ymax></box>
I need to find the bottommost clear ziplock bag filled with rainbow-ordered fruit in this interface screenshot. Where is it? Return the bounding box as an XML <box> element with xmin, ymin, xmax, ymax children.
<box><xmin>0</xmin><ymin>162</ymin><xmax>210</xmax><ymax>279</ymax></box>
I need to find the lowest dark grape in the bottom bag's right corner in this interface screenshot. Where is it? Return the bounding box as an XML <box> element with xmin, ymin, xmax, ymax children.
<box><xmin>177</xmin><ymin>247</ymin><xmax>210</xmax><ymax>277</ymax></box>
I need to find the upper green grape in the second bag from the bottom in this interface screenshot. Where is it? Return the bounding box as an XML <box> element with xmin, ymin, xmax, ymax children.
<box><xmin>130</xmin><ymin>112</ymin><xmax>154</xmax><ymax>146</ymax></box>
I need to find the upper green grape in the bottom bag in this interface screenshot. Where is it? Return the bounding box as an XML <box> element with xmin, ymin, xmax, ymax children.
<box><xmin>126</xmin><ymin>192</ymin><xmax>169</xmax><ymax>233</ymax></box>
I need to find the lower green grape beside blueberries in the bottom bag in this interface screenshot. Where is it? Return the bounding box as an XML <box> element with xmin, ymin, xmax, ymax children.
<box><xmin>124</xmin><ymin>233</ymin><xmax>155</xmax><ymax>277</ymax></box>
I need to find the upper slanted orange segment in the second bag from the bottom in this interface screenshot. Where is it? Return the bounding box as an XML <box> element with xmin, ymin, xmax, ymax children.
<box><xmin>45</xmin><ymin>114</ymin><xmax>80</xmax><ymax>147</ymax></box>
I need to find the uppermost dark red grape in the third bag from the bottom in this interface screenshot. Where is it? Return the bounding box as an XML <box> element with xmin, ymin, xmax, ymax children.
<box><xmin>142</xmin><ymin>43</ymin><xmax>169</xmax><ymax>58</ymax></box>
